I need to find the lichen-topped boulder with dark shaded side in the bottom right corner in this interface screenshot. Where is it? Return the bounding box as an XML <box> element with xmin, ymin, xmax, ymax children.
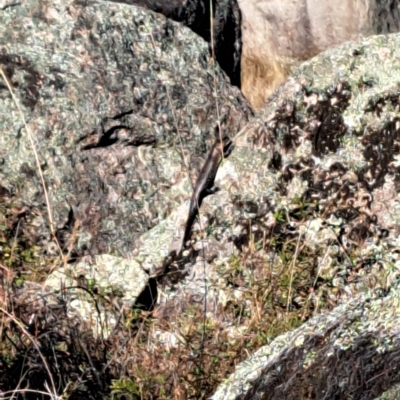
<box><xmin>211</xmin><ymin>285</ymin><xmax>400</xmax><ymax>400</ymax></box>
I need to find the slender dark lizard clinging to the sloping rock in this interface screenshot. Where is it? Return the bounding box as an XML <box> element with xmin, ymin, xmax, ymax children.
<box><xmin>182</xmin><ymin>135</ymin><xmax>233</xmax><ymax>247</ymax></box>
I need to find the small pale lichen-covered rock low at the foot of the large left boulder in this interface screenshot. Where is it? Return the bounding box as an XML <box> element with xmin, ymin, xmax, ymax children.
<box><xmin>44</xmin><ymin>254</ymin><xmax>149</xmax><ymax>339</ymax></box>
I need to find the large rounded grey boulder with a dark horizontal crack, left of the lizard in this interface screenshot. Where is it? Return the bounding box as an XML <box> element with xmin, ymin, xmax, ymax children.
<box><xmin>0</xmin><ymin>0</ymin><xmax>251</xmax><ymax>262</ymax></box>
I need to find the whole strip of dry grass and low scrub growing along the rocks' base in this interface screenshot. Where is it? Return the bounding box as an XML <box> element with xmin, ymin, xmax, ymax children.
<box><xmin>0</xmin><ymin>200</ymin><xmax>332</xmax><ymax>399</ymax></box>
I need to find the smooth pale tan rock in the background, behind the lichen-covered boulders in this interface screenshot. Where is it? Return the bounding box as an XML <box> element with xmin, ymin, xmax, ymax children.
<box><xmin>238</xmin><ymin>0</ymin><xmax>400</xmax><ymax>108</ymax></box>
